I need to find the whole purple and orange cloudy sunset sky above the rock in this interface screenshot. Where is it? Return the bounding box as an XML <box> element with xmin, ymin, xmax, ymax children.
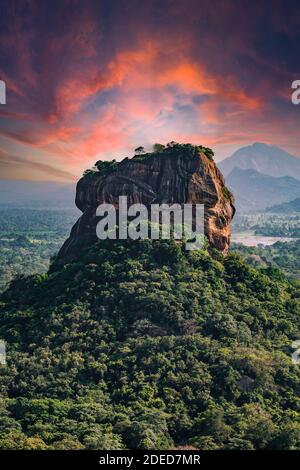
<box><xmin>0</xmin><ymin>0</ymin><xmax>300</xmax><ymax>181</ymax></box>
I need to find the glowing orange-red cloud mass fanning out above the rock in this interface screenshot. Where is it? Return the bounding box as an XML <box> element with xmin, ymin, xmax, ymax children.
<box><xmin>0</xmin><ymin>21</ymin><xmax>298</xmax><ymax>182</ymax></box>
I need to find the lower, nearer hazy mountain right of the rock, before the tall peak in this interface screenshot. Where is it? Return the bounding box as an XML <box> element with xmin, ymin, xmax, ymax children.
<box><xmin>226</xmin><ymin>168</ymin><xmax>300</xmax><ymax>211</ymax></box>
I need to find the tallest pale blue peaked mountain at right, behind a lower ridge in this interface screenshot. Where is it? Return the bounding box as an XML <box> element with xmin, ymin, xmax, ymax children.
<box><xmin>218</xmin><ymin>143</ymin><xmax>300</xmax><ymax>180</ymax></box>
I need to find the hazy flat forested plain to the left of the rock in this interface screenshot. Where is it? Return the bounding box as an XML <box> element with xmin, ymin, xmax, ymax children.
<box><xmin>0</xmin><ymin>207</ymin><xmax>79</xmax><ymax>292</ymax></box>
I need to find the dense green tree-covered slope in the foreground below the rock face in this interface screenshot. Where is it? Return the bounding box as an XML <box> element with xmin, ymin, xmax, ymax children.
<box><xmin>0</xmin><ymin>240</ymin><xmax>300</xmax><ymax>449</ymax></box>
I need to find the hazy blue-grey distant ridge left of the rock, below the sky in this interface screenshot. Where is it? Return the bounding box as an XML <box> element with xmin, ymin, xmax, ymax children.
<box><xmin>0</xmin><ymin>180</ymin><xmax>75</xmax><ymax>207</ymax></box>
